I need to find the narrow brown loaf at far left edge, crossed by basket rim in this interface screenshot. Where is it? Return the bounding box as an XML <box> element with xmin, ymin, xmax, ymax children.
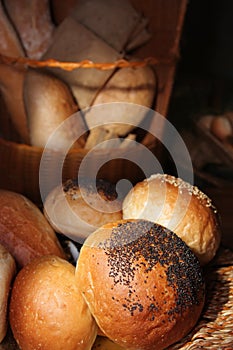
<box><xmin>0</xmin><ymin>1</ymin><xmax>29</xmax><ymax>143</ymax></box>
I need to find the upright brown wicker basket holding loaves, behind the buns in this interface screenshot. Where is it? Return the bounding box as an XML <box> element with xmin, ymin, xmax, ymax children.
<box><xmin>0</xmin><ymin>0</ymin><xmax>187</xmax><ymax>204</ymax></box>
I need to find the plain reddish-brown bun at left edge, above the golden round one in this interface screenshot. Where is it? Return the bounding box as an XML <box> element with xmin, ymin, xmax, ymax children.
<box><xmin>0</xmin><ymin>190</ymin><xmax>65</xmax><ymax>267</ymax></box>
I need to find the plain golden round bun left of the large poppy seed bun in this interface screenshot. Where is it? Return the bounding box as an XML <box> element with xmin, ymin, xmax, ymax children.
<box><xmin>10</xmin><ymin>256</ymin><xmax>97</xmax><ymax>350</ymax></box>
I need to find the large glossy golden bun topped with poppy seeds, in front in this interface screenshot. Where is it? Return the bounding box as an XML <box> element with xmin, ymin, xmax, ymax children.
<box><xmin>76</xmin><ymin>220</ymin><xmax>204</xmax><ymax>350</ymax></box>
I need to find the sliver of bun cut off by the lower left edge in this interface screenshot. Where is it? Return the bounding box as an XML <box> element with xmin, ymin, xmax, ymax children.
<box><xmin>0</xmin><ymin>244</ymin><xmax>16</xmax><ymax>343</ymax></box>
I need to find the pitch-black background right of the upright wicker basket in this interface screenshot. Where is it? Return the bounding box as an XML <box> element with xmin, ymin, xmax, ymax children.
<box><xmin>168</xmin><ymin>0</ymin><xmax>233</xmax><ymax>127</ymax></box>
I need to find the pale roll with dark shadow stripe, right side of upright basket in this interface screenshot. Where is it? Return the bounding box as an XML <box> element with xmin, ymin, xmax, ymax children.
<box><xmin>85</xmin><ymin>66</ymin><xmax>156</xmax><ymax>149</ymax></box>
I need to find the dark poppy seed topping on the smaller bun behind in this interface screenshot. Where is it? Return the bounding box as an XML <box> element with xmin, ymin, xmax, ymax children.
<box><xmin>63</xmin><ymin>178</ymin><xmax>118</xmax><ymax>201</ymax></box>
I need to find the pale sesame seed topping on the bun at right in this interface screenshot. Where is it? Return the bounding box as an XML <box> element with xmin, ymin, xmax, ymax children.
<box><xmin>149</xmin><ymin>174</ymin><xmax>217</xmax><ymax>213</ymax></box>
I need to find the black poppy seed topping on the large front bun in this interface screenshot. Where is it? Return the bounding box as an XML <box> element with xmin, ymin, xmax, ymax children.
<box><xmin>99</xmin><ymin>220</ymin><xmax>204</xmax><ymax>321</ymax></box>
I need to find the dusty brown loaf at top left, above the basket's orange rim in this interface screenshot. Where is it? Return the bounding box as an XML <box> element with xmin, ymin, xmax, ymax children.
<box><xmin>5</xmin><ymin>0</ymin><xmax>55</xmax><ymax>59</ymax></box>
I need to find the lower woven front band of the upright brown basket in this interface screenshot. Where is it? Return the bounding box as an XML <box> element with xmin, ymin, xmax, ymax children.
<box><xmin>0</xmin><ymin>134</ymin><xmax>159</xmax><ymax>205</ymax></box>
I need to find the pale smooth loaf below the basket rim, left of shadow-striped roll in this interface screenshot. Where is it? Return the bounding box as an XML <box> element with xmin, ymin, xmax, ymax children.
<box><xmin>24</xmin><ymin>69</ymin><xmax>85</xmax><ymax>150</ymax></box>
